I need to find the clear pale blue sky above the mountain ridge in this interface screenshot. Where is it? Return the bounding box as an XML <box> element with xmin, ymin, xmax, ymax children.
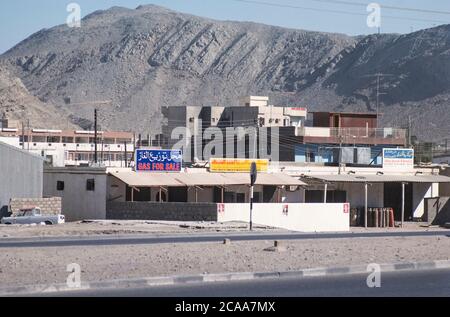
<box><xmin>0</xmin><ymin>0</ymin><xmax>450</xmax><ymax>53</ymax></box>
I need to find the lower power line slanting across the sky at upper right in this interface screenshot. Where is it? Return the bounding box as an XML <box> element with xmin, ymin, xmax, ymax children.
<box><xmin>232</xmin><ymin>0</ymin><xmax>449</xmax><ymax>24</ymax></box>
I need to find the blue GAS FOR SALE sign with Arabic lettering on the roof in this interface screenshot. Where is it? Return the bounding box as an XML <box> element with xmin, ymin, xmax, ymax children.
<box><xmin>136</xmin><ymin>150</ymin><xmax>183</xmax><ymax>172</ymax></box>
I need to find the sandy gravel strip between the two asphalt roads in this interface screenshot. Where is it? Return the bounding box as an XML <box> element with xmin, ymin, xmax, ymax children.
<box><xmin>0</xmin><ymin>236</ymin><xmax>450</xmax><ymax>288</ymax></box>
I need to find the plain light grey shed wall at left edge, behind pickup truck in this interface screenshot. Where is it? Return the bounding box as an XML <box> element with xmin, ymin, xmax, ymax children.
<box><xmin>0</xmin><ymin>143</ymin><xmax>44</xmax><ymax>218</ymax></box>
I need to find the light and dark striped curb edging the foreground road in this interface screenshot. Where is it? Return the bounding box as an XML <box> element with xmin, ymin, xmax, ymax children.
<box><xmin>0</xmin><ymin>260</ymin><xmax>450</xmax><ymax>297</ymax></box>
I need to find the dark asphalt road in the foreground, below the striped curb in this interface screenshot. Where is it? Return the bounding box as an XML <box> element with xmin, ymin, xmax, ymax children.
<box><xmin>40</xmin><ymin>269</ymin><xmax>450</xmax><ymax>298</ymax></box>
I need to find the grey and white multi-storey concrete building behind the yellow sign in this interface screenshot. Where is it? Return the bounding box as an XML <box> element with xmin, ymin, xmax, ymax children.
<box><xmin>162</xmin><ymin>96</ymin><xmax>307</xmax><ymax>162</ymax></box>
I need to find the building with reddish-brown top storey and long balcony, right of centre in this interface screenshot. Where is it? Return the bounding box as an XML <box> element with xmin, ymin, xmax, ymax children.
<box><xmin>295</xmin><ymin>112</ymin><xmax>407</xmax><ymax>165</ymax></box>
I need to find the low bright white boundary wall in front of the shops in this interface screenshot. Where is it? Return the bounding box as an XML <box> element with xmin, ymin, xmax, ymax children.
<box><xmin>217</xmin><ymin>203</ymin><xmax>350</xmax><ymax>232</ymax></box>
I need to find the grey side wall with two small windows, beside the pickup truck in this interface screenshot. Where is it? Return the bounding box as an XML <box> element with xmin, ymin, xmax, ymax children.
<box><xmin>44</xmin><ymin>168</ymin><xmax>106</xmax><ymax>221</ymax></box>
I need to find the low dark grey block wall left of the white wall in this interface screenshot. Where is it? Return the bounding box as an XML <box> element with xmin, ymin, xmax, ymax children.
<box><xmin>106</xmin><ymin>201</ymin><xmax>217</xmax><ymax>221</ymax></box>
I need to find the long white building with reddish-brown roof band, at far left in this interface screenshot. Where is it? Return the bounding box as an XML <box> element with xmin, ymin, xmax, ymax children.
<box><xmin>0</xmin><ymin>128</ymin><xmax>135</xmax><ymax>167</ymax></box>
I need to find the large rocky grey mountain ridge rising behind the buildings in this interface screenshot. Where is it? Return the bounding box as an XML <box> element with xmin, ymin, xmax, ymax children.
<box><xmin>0</xmin><ymin>5</ymin><xmax>450</xmax><ymax>139</ymax></box>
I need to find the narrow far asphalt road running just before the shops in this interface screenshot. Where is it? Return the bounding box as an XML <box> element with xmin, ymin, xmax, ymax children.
<box><xmin>0</xmin><ymin>230</ymin><xmax>450</xmax><ymax>249</ymax></box>
